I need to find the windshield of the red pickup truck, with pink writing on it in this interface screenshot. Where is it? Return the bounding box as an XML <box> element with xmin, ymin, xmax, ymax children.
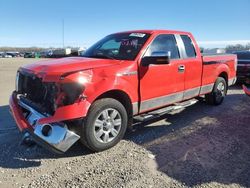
<box><xmin>82</xmin><ymin>33</ymin><xmax>150</xmax><ymax>60</ymax></box>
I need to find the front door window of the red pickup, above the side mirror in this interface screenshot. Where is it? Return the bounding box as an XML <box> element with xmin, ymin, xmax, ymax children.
<box><xmin>145</xmin><ymin>35</ymin><xmax>180</xmax><ymax>59</ymax></box>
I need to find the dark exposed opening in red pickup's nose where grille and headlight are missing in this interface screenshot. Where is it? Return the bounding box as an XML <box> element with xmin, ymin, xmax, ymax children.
<box><xmin>16</xmin><ymin>72</ymin><xmax>84</xmax><ymax>115</ymax></box>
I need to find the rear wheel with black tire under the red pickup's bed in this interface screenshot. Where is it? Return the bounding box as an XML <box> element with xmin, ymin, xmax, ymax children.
<box><xmin>205</xmin><ymin>77</ymin><xmax>228</xmax><ymax>105</ymax></box>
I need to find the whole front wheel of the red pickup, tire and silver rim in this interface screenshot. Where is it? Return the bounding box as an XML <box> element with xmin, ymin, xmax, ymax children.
<box><xmin>81</xmin><ymin>98</ymin><xmax>128</xmax><ymax>152</ymax></box>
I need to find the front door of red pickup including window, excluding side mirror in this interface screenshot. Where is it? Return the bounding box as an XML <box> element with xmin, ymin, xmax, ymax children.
<box><xmin>139</xmin><ymin>34</ymin><xmax>184</xmax><ymax>113</ymax></box>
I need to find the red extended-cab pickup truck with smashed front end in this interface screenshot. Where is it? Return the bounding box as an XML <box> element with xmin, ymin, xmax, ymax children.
<box><xmin>10</xmin><ymin>30</ymin><xmax>237</xmax><ymax>152</ymax></box>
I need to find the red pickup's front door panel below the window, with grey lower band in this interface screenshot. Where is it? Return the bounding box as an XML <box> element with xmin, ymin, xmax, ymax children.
<box><xmin>140</xmin><ymin>60</ymin><xmax>184</xmax><ymax>112</ymax></box>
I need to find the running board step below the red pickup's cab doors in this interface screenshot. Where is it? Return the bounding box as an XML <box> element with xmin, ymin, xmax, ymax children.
<box><xmin>134</xmin><ymin>99</ymin><xmax>199</xmax><ymax>124</ymax></box>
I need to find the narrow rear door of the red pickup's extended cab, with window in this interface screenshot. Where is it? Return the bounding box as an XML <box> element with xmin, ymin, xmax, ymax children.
<box><xmin>177</xmin><ymin>35</ymin><xmax>202</xmax><ymax>100</ymax></box>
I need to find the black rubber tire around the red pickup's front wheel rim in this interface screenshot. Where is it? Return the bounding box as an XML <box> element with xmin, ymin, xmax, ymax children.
<box><xmin>81</xmin><ymin>98</ymin><xmax>128</xmax><ymax>152</ymax></box>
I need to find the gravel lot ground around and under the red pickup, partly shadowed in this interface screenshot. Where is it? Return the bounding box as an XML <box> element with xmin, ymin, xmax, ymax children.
<box><xmin>0</xmin><ymin>59</ymin><xmax>250</xmax><ymax>188</ymax></box>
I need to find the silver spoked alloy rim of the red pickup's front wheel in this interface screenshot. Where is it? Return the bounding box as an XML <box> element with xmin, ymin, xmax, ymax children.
<box><xmin>94</xmin><ymin>108</ymin><xmax>122</xmax><ymax>143</ymax></box>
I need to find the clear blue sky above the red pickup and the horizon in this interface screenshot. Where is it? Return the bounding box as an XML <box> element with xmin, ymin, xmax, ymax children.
<box><xmin>0</xmin><ymin>0</ymin><xmax>250</xmax><ymax>47</ymax></box>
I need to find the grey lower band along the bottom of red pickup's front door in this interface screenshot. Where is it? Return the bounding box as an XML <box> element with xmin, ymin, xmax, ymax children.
<box><xmin>140</xmin><ymin>92</ymin><xmax>183</xmax><ymax>112</ymax></box>
